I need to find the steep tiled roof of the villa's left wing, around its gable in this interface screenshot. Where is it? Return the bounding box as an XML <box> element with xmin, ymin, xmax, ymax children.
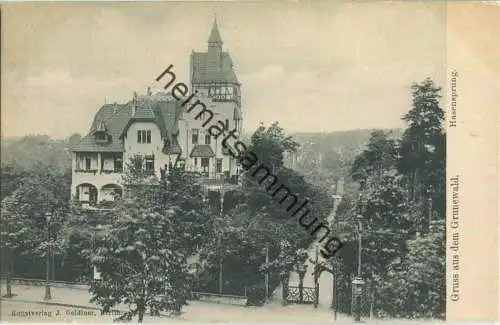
<box><xmin>71</xmin><ymin>93</ymin><xmax>182</xmax><ymax>153</ymax></box>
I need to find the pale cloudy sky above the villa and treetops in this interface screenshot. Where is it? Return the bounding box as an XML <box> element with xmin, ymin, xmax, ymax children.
<box><xmin>2</xmin><ymin>1</ymin><xmax>446</xmax><ymax>138</ymax></box>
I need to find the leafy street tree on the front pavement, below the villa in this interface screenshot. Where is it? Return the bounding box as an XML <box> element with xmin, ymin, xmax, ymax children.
<box><xmin>90</xmin><ymin>196</ymin><xmax>190</xmax><ymax>322</ymax></box>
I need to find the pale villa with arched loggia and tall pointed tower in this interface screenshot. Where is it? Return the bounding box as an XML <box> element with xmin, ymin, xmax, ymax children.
<box><xmin>71</xmin><ymin>21</ymin><xmax>243</xmax><ymax>207</ymax></box>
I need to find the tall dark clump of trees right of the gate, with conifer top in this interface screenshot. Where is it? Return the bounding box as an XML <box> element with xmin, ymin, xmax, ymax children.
<box><xmin>336</xmin><ymin>79</ymin><xmax>446</xmax><ymax>317</ymax></box>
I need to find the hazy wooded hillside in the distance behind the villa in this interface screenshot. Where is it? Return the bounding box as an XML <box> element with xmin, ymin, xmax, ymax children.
<box><xmin>1</xmin><ymin>129</ymin><xmax>402</xmax><ymax>197</ymax></box>
